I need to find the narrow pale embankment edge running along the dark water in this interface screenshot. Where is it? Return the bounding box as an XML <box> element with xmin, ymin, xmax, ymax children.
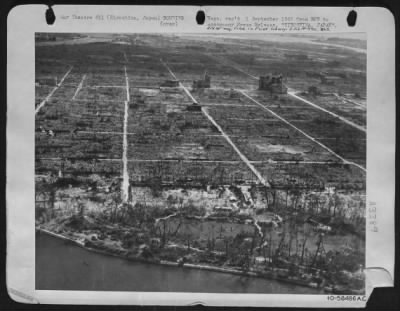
<box><xmin>36</xmin><ymin>227</ymin><xmax>331</xmax><ymax>294</ymax></box>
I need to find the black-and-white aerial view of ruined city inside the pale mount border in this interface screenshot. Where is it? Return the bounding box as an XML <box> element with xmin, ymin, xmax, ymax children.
<box><xmin>35</xmin><ymin>33</ymin><xmax>367</xmax><ymax>295</ymax></box>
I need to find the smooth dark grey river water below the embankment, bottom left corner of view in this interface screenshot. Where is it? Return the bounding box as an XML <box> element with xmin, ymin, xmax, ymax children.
<box><xmin>36</xmin><ymin>233</ymin><xmax>319</xmax><ymax>294</ymax></box>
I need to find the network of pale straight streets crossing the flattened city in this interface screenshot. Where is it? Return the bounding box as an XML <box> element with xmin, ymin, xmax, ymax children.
<box><xmin>35</xmin><ymin>40</ymin><xmax>366</xmax><ymax>191</ymax></box>
